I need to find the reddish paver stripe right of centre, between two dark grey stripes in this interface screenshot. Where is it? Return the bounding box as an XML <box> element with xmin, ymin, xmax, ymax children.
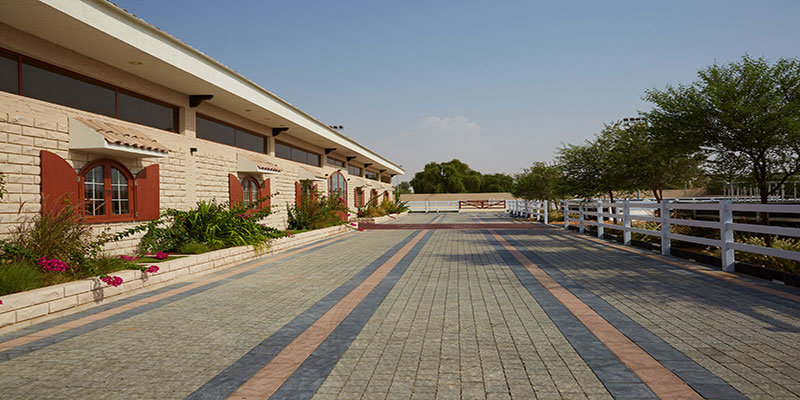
<box><xmin>491</xmin><ymin>232</ymin><xmax>702</xmax><ymax>399</ymax></box>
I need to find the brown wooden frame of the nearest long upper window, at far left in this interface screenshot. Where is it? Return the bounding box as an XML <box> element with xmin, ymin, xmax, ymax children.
<box><xmin>0</xmin><ymin>47</ymin><xmax>180</xmax><ymax>134</ymax></box>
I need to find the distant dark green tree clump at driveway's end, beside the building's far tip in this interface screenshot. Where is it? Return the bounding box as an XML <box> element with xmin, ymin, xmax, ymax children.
<box><xmin>410</xmin><ymin>159</ymin><xmax>513</xmax><ymax>193</ymax></box>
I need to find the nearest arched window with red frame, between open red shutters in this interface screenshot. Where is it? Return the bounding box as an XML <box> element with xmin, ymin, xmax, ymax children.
<box><xmin>80</xmin><ymin>160</ymin><xmax>134</xmax><ymax>222</ymax></box>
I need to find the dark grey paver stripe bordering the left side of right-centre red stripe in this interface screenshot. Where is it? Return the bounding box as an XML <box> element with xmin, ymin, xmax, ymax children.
<box><xmin>482</xmin><ymin>228</ymin><xmax>656</xmax><ymax>399</ymax></box>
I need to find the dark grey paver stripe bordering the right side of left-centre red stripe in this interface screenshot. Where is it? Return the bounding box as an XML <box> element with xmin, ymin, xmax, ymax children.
<box><xmin>271</xmin><ymin>231</ymin><xmax>433</xmax><ymax>399</ymax></box>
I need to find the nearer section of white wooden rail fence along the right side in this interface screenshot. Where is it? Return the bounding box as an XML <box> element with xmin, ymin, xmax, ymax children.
<box><xmin>563</xmin><ymin>200</ymin><xmax>800</xmax><ymax>272</ymax></box>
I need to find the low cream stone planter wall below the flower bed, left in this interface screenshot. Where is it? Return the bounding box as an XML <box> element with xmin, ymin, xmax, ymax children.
<box><xmin>0</xmin><ymin>225</ymin><xmax>352</xmax><ymax>334</ymax></box>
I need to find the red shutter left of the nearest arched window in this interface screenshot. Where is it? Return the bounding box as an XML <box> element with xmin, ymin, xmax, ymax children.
<box><xmin>40</xmin><ymin>150</ymin><xmax>81</xmax><ymax>215</ymax></box>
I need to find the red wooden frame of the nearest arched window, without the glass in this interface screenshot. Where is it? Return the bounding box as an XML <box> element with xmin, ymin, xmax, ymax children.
<box><xmin>78</xmin><ymin>158</ymin><xmax>137</xmax><ymax>223</ymax></box>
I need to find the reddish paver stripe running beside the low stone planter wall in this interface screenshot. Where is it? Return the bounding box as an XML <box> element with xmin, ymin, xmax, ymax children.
<box><xmin>0</xmin><ymin>237</ymin><xmax>344</xmax><ymax>352</ymax></box>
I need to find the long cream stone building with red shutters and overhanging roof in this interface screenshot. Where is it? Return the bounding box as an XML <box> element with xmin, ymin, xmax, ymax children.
<box><xmin>0</xmin><ymin>0</ymin><xmax>403</xmax><ymax>251</ymax></box>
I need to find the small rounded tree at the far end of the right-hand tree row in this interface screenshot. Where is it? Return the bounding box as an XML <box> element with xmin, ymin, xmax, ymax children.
<box><xmin>511</xmin><ymin>161</ymin><xmax>565</xmax><ymax>204</ymax></box>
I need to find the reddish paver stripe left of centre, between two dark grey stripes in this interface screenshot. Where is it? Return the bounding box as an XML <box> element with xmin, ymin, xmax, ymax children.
<box><xmin>228</xmin><ymin>231</ymin><xmax>427</xmax><ymax>399</ymax></box>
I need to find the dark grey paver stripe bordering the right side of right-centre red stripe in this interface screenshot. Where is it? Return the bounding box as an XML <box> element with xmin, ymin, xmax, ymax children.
<box><xmin>498</xmin><ymin>231</ymin><xmax>747</xmax><ymax>400</ymax></box>
